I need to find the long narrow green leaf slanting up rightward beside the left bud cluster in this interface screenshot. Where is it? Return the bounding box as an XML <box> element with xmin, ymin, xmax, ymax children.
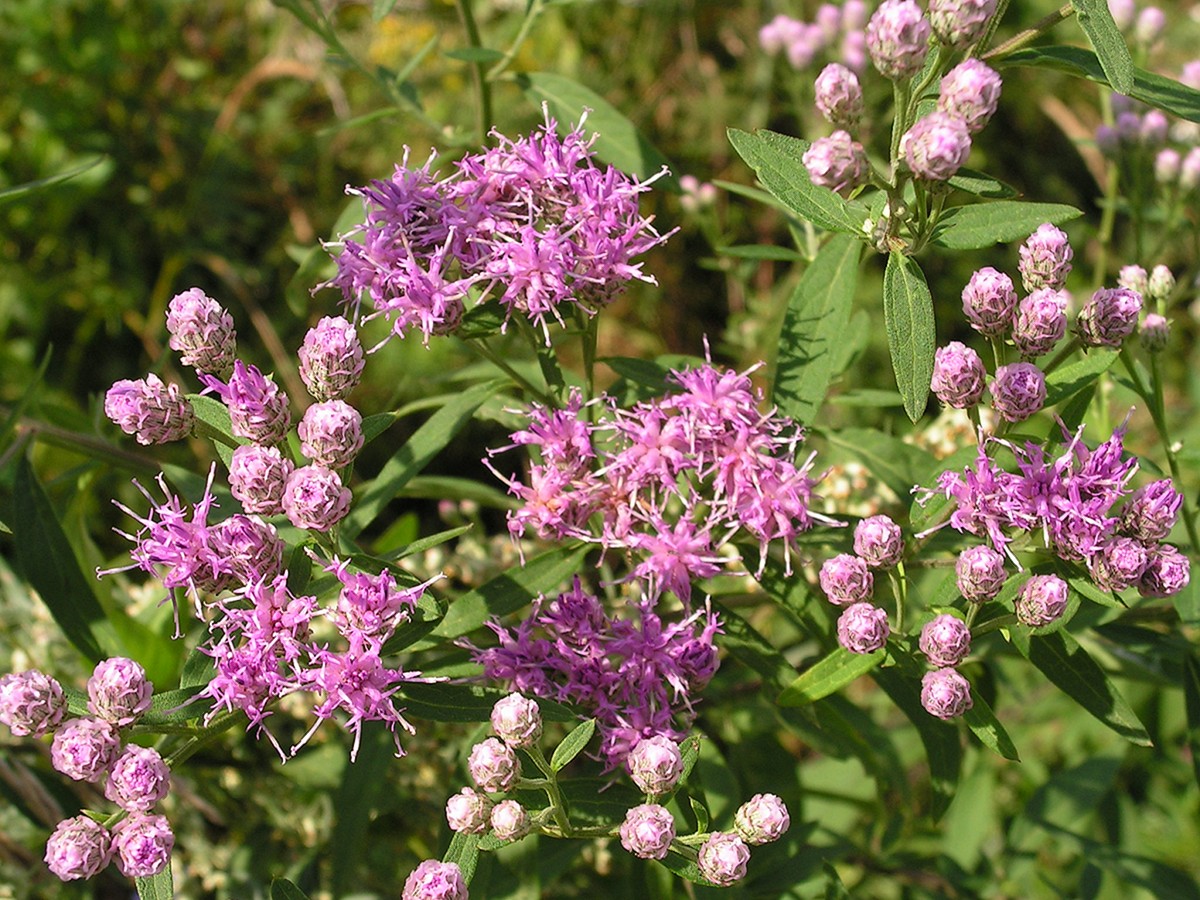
<box><xmin>342</xmin><ymin>379</ymin><xmax>508</xmax><ymax>540</ymax></box>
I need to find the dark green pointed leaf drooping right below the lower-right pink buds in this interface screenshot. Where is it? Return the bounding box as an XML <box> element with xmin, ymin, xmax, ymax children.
<box><xmin>1010</xmin><ymin>629</ymin><xmax>1153</xmax><ymax>746</ymax></box>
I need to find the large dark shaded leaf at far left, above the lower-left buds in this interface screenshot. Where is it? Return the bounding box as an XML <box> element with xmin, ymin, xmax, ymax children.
<box><xmin>12</xmin><ymin>457</ymin><xmax>108</xmax><ymax>662</ymax></box>
